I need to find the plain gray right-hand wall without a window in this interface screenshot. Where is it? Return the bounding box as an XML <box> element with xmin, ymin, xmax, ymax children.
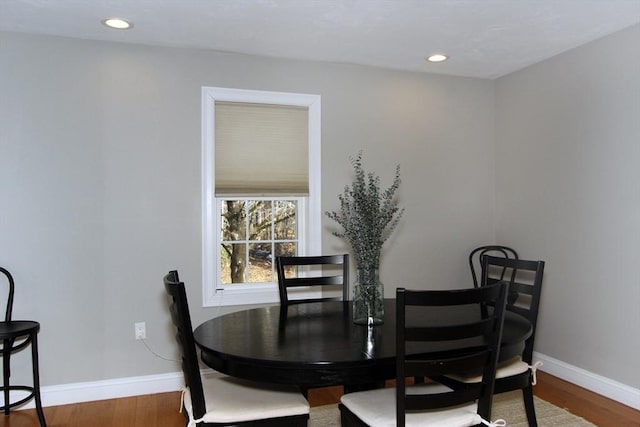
<box><xmin>495</xmin><ymin>25</ymin><xmax>640</xmax><ymax>388</ymax></box>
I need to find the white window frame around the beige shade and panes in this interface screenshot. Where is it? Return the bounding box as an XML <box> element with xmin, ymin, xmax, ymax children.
<box><xmin>202</xmin><ymin>87</ymin><xmax>322</xmax><ymax>307</ymax></box>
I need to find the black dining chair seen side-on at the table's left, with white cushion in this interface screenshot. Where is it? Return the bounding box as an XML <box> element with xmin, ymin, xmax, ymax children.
<box><xmin>164</xmin><ymin>270</ymin><xmax>309</xmax><ymax>427</ymax></box>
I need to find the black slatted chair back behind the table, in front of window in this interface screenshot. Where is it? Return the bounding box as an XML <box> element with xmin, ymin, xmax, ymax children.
<box><xmin>276</xmin><ymin>254</ymin><xmax>349</xmax><ymax>306</ymax></box>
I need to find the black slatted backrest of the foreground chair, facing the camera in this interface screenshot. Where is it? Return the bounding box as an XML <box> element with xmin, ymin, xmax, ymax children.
<box><xmin>396</xmin><ymin>282</ymin><xmax>508</xmax><ymax>426</ymax></box>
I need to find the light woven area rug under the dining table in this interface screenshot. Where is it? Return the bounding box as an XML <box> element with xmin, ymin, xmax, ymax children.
<box><xmin>309</xmin><ymin>391</ymin><xmax>594</xmax><ymax>427</ymax></box>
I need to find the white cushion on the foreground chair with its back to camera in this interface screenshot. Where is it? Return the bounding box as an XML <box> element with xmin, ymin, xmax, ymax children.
<box><xmin>340</xmin><ymin>383</ymin><xmax>482</xmax><ymax>427</ymax></box>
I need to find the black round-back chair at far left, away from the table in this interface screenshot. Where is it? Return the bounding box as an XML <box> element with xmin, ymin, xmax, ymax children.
<box><xmin>0</xmin><ymin>267</ymin><xmax>47</xmax><ymax>427</ymax></box>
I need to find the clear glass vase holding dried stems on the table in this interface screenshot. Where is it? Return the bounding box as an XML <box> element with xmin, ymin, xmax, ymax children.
<box><xmin>353</xmin><ymin>269</ymin><xmax>384</xmax><ymax>326</ymax></box>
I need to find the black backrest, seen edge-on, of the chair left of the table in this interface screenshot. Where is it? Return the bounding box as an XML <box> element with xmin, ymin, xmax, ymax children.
<box><xmin>164</xmin><ymin>270</ymin><xmax>206</xmax><ymax>419</ymax></box>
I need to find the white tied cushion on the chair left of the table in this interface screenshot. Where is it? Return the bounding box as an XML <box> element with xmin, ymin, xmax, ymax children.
<box><xmin>183</xmin><ymin>374</ymin><xmax>309</xmax><ymax>426</ymax></box>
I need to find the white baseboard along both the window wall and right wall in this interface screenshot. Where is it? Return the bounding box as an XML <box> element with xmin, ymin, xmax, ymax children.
<box><xmin>16</xmin><ymin>360</ymin><xmax>640</xmax><ymax>410</ymax></box>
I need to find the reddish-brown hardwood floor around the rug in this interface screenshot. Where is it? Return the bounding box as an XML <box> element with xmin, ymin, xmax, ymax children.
<box><xmin>0</xmin><ymin>371</ymin><xmax>640</xmax><ymax>427</ymax></box>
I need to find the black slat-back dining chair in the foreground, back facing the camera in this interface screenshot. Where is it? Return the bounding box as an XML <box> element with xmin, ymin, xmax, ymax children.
<box><xmin>339</xmin><ymin>283</ymin><xmax>507</xmax><ymax>427</ymax></box>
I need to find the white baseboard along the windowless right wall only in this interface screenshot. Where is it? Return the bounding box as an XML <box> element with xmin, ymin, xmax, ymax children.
<box><xmin>533</xmin><ymin>352</ymin><xmax>640</xmax><ymax>410</ymax></box>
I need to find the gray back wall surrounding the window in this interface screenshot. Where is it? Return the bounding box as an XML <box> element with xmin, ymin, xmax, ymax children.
<box><xmin>0</xmin><ymin>33</ymin><xmax>496</xmax><ymax>385</ymax></box>
